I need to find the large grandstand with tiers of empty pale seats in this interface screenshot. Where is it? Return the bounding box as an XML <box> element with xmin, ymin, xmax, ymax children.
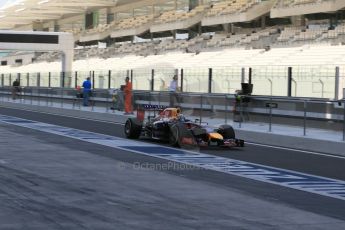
<box><xmin>0</xmin><ymin>0</ymin><xmax>345</xmax><ymax>98</ymax></box>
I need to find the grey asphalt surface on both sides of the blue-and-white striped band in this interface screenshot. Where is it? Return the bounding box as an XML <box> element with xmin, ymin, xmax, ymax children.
<box><xmin>0</xmin><ymin>108</ymin><xmax>345</xmax><ymax>229</ymax></box>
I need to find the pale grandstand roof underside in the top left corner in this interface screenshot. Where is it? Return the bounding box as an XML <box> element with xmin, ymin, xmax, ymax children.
<box><xmin>0</xmin><ymin>0</ymin><xmax>181</xmax><ymax>29</ymax></box>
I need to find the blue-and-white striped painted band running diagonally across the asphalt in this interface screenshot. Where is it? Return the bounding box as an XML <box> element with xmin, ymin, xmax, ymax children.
<box><xmin>0</xmin><ymin>115</ymin><xmax>345</xmax><ymax>200</ymax></box>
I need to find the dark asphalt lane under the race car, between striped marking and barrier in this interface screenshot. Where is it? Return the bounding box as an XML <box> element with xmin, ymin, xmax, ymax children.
<box><xmin>0</xmin><ymin>107</ymin><xmax>345</xmax><ymax>180</ymax></box>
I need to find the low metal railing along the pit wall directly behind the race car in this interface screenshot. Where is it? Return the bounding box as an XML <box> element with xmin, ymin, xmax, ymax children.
<box><xmin>0</xmin><ymin>87</ymin><xmax>345</xmax><ymax>140</ymax></box>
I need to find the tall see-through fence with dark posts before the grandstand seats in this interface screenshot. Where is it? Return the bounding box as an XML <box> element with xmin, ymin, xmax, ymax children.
<box><xmin>0</xmin><ymin>64</ymin><xmax>344</xmax><ymax>99</ymax></box>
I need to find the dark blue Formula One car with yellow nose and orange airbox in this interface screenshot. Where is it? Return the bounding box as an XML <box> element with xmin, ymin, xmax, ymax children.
<box><xmin>125</xmin><ymin>108</ymin><xmax>244</xmax><ymax>147</ymax></box>
